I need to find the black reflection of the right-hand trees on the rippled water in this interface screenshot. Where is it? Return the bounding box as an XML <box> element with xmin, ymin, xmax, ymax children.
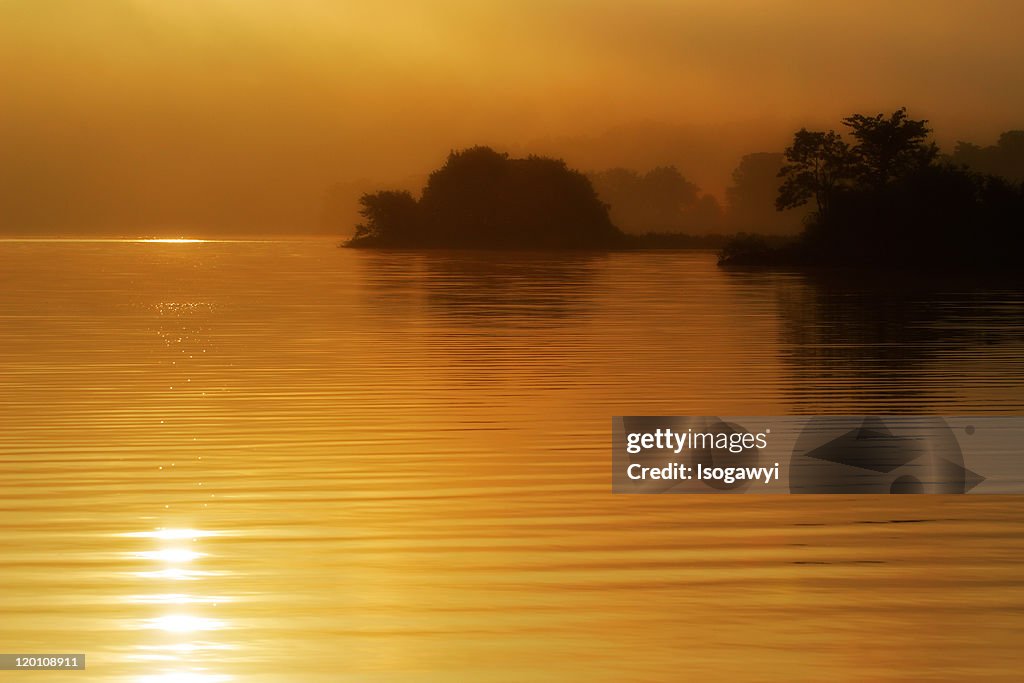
<box><xmin>777</xmin><ymin>275</ymin><xmax>1024</xmax><ymax>413</ymax></box>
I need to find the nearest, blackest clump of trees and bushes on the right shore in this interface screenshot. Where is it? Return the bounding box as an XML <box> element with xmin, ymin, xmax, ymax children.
<box><xmin>721</xmin><ymin>109</ymin><xmax>1024</xmax><ymax>270</ymax></box>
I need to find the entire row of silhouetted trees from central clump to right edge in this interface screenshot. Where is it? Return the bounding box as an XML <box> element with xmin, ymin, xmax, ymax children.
<box><xmin>347</xmin><ymin>114</ymin><xmax>1024</xmax><ymax>267</ymax></box>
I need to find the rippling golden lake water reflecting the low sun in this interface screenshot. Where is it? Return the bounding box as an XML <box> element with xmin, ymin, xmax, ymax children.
<box><xmin>0</xmin><ymin>241</ymin><xmax>1024</xmax><ymax>683</ymax></box>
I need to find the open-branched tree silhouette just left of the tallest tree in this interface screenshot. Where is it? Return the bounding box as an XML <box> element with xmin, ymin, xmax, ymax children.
<box><xmin>775</xmin><ymin>128</ymin><xmax>853</xmax><ymax>216</ymax></box>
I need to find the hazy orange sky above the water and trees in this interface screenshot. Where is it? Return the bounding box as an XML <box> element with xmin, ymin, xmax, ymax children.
<box><xmin>0</xmin><ymin>0</ymin><xmax>1024</xmax><ymax>233</ymax></box>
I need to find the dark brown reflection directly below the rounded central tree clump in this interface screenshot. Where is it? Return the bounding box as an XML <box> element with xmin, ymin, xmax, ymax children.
<box><xmin>361</xmin><ymin>251</ymin><xmax>605</xmax><ymax>328</ymax></box>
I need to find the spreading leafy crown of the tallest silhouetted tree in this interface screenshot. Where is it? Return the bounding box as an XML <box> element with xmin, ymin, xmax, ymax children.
<box><xmin>843</xmin><ymin>106</ymin><xmax>939</xmax><ymax>188</ymax></box>
